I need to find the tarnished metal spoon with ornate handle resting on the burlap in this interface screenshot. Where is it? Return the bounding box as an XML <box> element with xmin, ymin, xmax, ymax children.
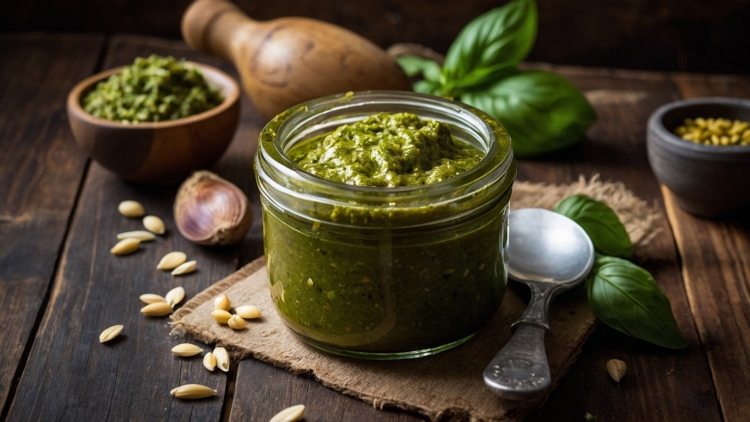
<box><xmin>484</xmin><ymin>208</ymin><xmax>594</xmax><ymax>400</ymax></box>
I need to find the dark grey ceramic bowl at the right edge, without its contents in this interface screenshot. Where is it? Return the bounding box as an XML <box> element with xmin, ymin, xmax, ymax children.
<box><xmin>647</xmin><ymin>97</ymin><xmax>750</xmax><ymax>218</ymax></box>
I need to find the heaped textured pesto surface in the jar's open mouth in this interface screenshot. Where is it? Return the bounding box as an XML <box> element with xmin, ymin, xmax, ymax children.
<box><xmin>287</xmin><ymin>113</ymin><xmax>484</xmax><ymax>187</ymax></box>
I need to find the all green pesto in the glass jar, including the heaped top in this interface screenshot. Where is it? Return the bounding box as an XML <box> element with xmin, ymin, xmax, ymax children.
<box><xmin>263</xmin><ymin>113</ymin><xmax>515</xmax><ymax>353</ymax></box>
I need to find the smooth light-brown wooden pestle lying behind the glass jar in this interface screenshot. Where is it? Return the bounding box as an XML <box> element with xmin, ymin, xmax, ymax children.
<box><xmin>182</xmin><ymin>0</ymin><xmax>411</xmax><ymax>119</ymax></box>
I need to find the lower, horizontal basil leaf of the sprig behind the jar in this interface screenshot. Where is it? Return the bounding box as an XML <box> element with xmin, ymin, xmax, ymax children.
<box><xmin>460</xmin><ymin>71</ymin><xmax>596</xmax><ymax>157</ymax></box>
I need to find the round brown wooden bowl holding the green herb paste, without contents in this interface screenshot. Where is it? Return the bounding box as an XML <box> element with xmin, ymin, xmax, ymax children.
<box><xmin>67</xmin><ymin>62</ymin><xmax>240</xmax><ymax>184</ymax></box>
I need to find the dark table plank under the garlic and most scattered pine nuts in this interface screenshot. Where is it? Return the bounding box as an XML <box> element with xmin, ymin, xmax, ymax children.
<box><xmin>3</xmin><ymin>37</ymin><xmax>260</xmax><ymax>421</ymax></box>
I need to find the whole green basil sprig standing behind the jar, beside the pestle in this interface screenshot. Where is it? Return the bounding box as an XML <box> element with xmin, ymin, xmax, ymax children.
<box><xmin>398</xmin><ymin>0</ymin><xmax>596</xmax><ymax>157</ymax></box>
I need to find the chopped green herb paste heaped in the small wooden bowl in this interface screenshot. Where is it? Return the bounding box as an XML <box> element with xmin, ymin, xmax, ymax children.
<box><xmin>83</xmin><ymin>54</ymin><xmax>224</xmax><ymax>123</ymax></box>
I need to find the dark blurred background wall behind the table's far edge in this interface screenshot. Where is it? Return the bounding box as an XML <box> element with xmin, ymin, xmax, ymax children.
<box><xmin>0</xmin><ymin>0</ymin><xmax>750</xmax><ymax>74</ymax></box>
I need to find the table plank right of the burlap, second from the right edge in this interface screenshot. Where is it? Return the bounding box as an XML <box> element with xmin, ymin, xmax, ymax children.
<box><xmin>519</xmin><ymin>66</ymin><xmax>720</xmax><ymax>421</ymax></box>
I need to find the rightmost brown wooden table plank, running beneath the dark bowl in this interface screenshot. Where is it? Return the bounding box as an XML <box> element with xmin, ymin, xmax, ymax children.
<box><xmin>662</xmin><ymin>74</ymin><xmax>750</xmax><ymax>422</ymax></box>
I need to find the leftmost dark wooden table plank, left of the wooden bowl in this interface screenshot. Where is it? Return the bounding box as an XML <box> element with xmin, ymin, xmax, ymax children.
<box><xmin>0</xmin><ymin>34</ymin><xmax>104</xmax><ymax>413</ymax></box>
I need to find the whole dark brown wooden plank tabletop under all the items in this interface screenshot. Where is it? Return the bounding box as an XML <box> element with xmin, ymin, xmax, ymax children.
<box><xmin>0</xmin><ymin>33</ymin><xmax>750</xmax><ymax>421</ymax></box>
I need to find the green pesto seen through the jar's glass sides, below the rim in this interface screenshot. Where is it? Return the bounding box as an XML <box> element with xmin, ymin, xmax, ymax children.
<box><xmin>263</xmin><ymin>203</ymin><xmax>508</xmax><ymax>353</ymax></box>
